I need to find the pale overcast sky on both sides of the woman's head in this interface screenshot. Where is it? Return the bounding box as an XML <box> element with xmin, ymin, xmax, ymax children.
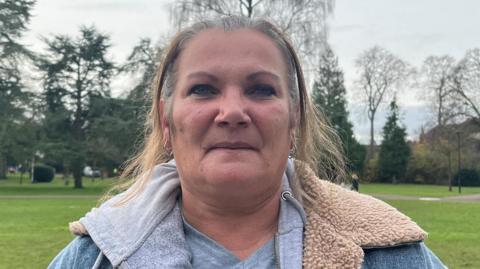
<box><xmin>24</xmin><ymin>0</ymin><xmax>480</xmax><ymax>143</ymax></box>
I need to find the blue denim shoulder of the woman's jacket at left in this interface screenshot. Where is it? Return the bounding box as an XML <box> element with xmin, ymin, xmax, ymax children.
<box><xmin>48</xmin><ymin>236</ymin><xmax>111</xmax><ymax>269</ymax></box>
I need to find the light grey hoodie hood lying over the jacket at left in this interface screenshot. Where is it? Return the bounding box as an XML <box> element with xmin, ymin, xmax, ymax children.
<box><xmin>78</xmin><ymin>161</ymin><xmax>180</xmax><ymax>266</ymax></box>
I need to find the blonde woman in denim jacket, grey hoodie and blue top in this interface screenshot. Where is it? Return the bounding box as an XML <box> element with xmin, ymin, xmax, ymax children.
<box><xmin>50</xmin><ymin>17</ymin><xmax>443</xmax><ymax>268</ymax></box>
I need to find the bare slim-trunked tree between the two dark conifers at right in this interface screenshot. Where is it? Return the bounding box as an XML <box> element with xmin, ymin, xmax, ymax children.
<box><xmin>355</xmin><ymin>46</ymin><xmax>412</xmax><ymax>160</ymax></box>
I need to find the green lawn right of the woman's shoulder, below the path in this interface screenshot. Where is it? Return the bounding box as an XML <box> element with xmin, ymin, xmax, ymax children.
<box><xmin>387</xmin><ymin>201</ymin><xmax>480</xmax><ymax>269</ymax></box>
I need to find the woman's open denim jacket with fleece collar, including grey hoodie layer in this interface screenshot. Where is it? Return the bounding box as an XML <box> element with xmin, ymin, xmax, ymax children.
<box><xmin>49</xmin><ymin>160</ymin><xmax>445</xmax><ymax>269</ymax></box>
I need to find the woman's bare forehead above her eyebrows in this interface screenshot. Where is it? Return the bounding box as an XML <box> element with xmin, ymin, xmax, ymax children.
<box><xmin>178</xmin><ymin>29</ymin><xmax>287</xmax><ymax>77</ymax></box>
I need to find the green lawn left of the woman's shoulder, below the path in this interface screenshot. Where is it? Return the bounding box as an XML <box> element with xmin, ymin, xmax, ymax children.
<box><xmin>0</xmin><ymin>199</ymin><xmax>96</xmax><ymax>269</ymax></box>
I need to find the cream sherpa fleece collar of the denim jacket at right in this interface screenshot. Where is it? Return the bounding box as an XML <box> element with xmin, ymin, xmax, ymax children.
<box><xmin>295</xmin><ymin>162</ymin><xmax>426</xmax><ymax>268</ymax></box>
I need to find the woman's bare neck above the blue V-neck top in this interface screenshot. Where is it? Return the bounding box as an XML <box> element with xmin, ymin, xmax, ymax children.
<box><xmin>182</xmin><ymin>185</ymin><xmax>280</xmax><ymax>260</ymax></box>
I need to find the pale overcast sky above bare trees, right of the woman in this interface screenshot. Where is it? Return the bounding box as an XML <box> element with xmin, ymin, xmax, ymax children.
<box><xmin>329</xmin><ymin>0</ymin><xmax>480</xmax><ymax>143</ymax></box>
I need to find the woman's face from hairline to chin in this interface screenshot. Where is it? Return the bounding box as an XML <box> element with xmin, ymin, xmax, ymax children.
<box><xmin>163</xmin><ymin>29</ymin><xmax>294</xmax><ymax>201</ymax></box>
